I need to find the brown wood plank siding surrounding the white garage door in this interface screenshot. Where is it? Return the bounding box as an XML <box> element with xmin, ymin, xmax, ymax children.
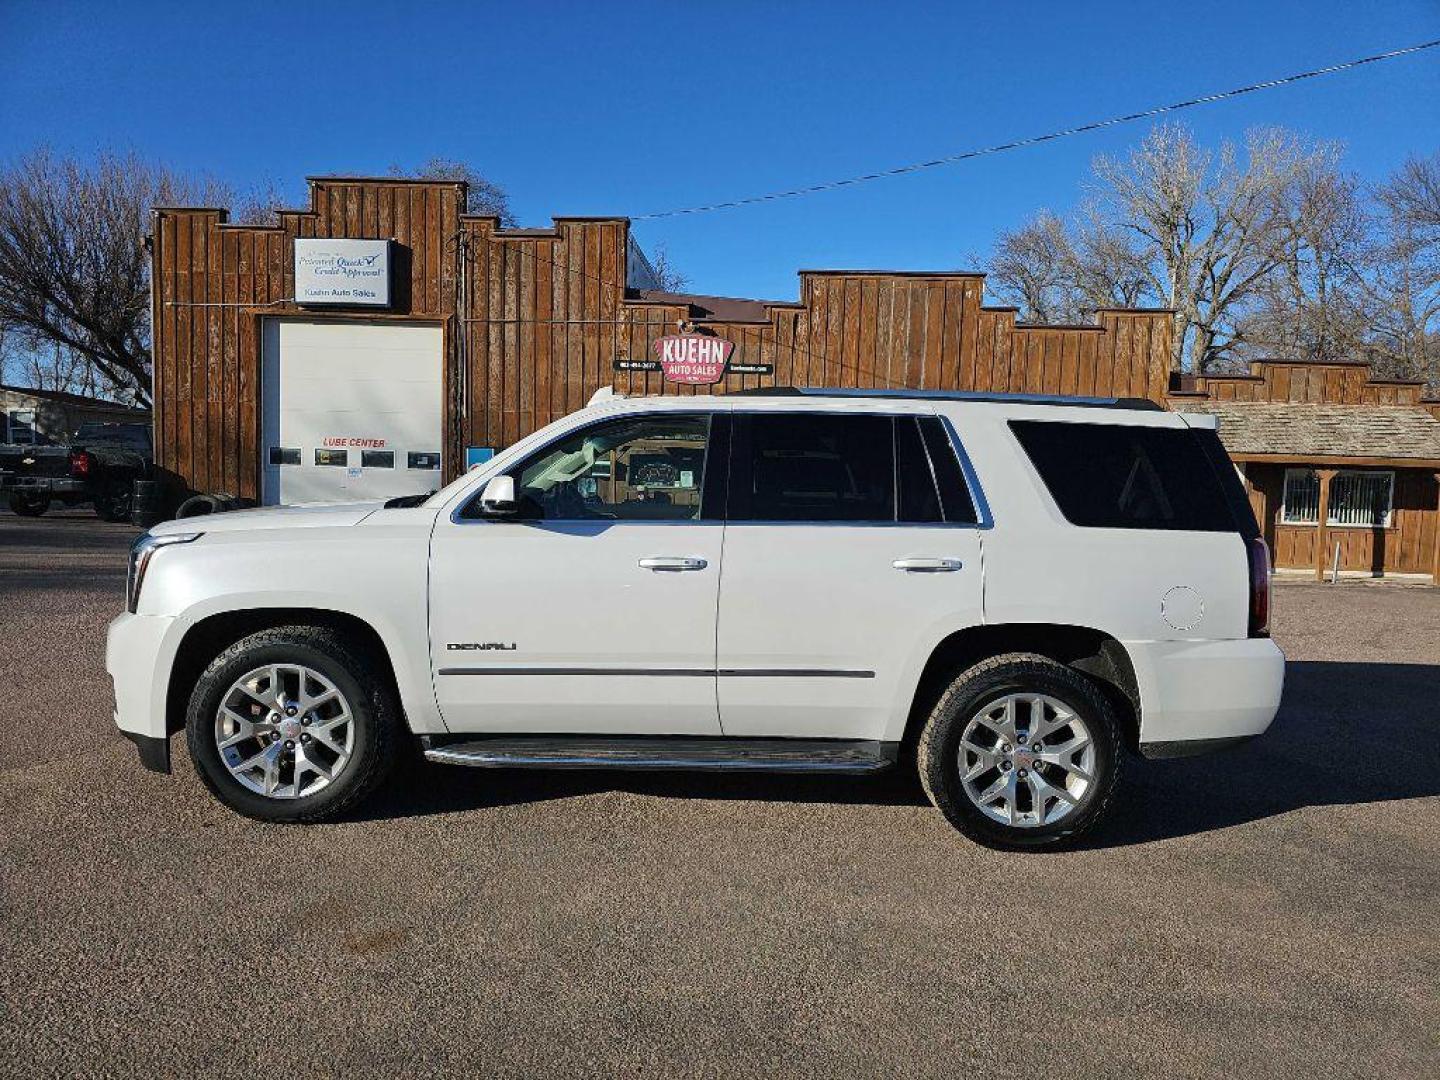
<box><xmin>151</xmin><ymin>180</ymin><xmax>464</xmax><ymax>498</ymax></box>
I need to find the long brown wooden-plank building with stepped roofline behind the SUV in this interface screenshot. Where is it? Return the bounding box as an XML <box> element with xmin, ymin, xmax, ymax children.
<box><xmin>151</xmin><ymin>177</ymin><xmax>1440</xmax><ymax>584</ymax></box>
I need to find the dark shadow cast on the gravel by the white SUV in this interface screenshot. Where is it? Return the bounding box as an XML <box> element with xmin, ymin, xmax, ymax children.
<box><xmin>357</xmin><ymin>661</ymin><xmax>1440</xmax><ymax>848</ymax></box>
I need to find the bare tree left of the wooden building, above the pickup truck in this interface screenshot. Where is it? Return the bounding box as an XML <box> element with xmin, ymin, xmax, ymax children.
<box><xmin>0</xmin><ymin>150</ymin><xmax>226</xmax><ymax>405</ymax></box>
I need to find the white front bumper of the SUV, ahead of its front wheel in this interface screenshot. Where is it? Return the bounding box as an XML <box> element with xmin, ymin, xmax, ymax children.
<box><xmin>105</xmin><ymin>612</ymin><xmax>174</xmax><ymax>772</ymax></box>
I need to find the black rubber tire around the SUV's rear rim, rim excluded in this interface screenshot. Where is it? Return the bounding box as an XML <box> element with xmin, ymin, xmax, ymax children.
<box><xmin>916</xmin><ymin>652</ymin><xmax>1123</xmax><ymax>851</ymax></box>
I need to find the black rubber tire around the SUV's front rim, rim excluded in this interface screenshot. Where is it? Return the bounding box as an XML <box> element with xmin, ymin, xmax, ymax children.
<box><xmin>186</xmin><ymin>626</ymin><xmax>402</xmax><ymax>822</ymax></box>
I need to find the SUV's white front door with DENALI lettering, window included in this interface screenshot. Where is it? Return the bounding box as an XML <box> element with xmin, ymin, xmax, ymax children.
<box><xmin>431</xmin><ymin>410</ymin><xmax>724</xmax><ymax>734</ymax></box>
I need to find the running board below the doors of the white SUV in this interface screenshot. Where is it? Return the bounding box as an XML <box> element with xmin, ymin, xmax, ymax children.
<box><xmin>423</xmin><ymin>736</ymin><xmax>900</xmax><ymax>773</ymax></box>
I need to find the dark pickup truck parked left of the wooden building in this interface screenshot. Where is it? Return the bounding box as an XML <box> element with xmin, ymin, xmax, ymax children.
<box><xmin>0</xmin><ymin>423</ymin><xmax>154</xmax><ymax>521</ymax></box>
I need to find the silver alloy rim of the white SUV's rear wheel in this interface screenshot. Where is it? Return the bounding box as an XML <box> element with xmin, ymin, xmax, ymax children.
<box><xmin>958</xmin><ymin>694</ymin><xmax>1094</xmax><ymax>828</ymax></box>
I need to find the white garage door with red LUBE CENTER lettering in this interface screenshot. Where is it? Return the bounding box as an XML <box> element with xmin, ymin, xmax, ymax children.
<box><xmin>261</xmin><ymin>318</ymin><xmax>444</xmax><ymax>504</ymax></box>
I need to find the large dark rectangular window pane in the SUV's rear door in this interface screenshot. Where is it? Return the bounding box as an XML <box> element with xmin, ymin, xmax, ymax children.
<box><xmin>729</xmin><ymin>412</ymin><xmax>896</xmax><ymax>521</ymax></box>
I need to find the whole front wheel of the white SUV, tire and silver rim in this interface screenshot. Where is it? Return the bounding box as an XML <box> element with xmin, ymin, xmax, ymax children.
<box><xmin>186</xmin><ymin>626</ymin><xmax>400</xmax><ymax>822</ymax></box>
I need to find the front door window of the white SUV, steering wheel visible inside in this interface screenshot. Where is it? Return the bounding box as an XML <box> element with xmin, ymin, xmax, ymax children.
<box><xmin>478</xmin><ymin>413</ymin><xmax>710</xmax><ymax>521</ymax></box>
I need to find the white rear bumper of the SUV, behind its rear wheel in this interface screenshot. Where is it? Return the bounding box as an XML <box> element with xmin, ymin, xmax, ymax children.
<box><xmin>1125</xmin><ymin>638</ymin><xmax>1284</xmax><ymax>757</ymax></box>
